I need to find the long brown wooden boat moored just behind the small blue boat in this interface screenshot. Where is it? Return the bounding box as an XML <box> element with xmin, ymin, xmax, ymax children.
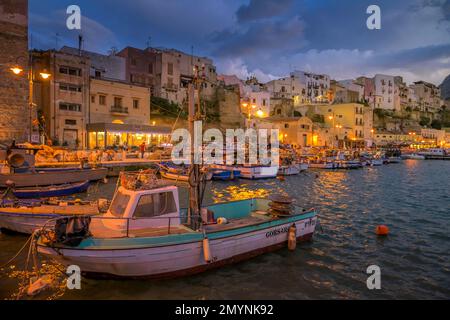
<box><xmin>0</xmin><ymin>168</ymin><xmax>108</xmax><ymax>188</ymax></box>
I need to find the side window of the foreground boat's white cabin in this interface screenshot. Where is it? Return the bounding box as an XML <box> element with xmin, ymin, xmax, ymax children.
<box><xmin>134</xmin><ymin>192</ymin><xmax>177</xmax><ymax>218</ymax></box>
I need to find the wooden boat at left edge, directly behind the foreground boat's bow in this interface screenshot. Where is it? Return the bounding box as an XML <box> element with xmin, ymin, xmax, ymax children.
<box><xmin>0</xmin><ymin>200</ymin><xmax>99</xmax><ymax>234</ymax></box>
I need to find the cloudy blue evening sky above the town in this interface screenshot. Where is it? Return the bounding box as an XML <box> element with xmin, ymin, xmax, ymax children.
<box><xmin>30</xmin><ymin>0</ymin><xmax>450</xmax><ymax>84</ymax></box>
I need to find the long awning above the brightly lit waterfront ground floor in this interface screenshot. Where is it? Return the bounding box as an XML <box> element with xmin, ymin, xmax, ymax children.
<box><xmin>86</xmin><ymin>123</ymin><xmax>172</xmax><ymax>135</ymax></box>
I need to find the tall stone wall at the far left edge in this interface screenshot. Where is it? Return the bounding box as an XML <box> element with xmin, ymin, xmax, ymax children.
<box><xmin>0</xmin><ymin>0</ymin><xmax>29</xmax><ymax>143</ymax></box>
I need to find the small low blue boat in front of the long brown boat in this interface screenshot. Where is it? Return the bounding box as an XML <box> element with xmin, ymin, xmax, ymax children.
<box><xmin>12</xmin><ymin>181</ymin><xmax>90</xmax><ymax>199</ymax></box>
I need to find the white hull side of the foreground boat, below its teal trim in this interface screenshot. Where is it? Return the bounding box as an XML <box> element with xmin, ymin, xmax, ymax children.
<box><xmin>38</xmin><ymin>216</ymin><xmax>317</xmax><ymax>278</ymax></box>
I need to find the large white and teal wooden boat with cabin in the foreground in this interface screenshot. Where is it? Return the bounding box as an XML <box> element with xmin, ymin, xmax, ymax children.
<box><xmin>37</xmin><ymin>173</ymin><xmax>317</xmax><ymax>278</ymax></box>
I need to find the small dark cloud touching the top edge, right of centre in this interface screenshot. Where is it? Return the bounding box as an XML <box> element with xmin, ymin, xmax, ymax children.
<box><xmin>236</xmin><ymin>0</ymin><xmax>293</xmax><ymax>22</ymax></box>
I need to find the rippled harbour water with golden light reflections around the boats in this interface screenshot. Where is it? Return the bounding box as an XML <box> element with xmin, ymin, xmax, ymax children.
<box><xmin>0</xmin><ymin>160</ymin><xmax>450</xmax><ymax>299</ymax></box>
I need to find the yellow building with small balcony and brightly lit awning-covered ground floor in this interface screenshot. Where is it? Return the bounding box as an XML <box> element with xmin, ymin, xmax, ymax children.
<box><xmin>87</xmin><ymin>78</ymin><xmax>170</xmax><ymax>149</ymax></box>
